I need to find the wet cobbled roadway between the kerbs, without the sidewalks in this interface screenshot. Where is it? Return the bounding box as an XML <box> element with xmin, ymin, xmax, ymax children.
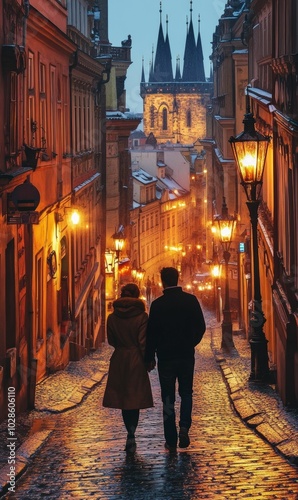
<box><xmin>4</xmin><ymin>314</ymin><xmax>298</xmax><ymax>500</ymax></box>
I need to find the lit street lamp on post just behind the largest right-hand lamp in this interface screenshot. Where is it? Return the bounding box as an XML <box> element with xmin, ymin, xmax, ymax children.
<box><xmin>214</xmin><ymin>198</ymin><xmax>236</xmax><ymax>351</ymax></box>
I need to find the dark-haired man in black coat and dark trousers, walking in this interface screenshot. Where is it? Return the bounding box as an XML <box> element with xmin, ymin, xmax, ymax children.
<box><xmin>145</xmin><ymin>267</ymin><xmax>206</xmax><ymax>451</ymax></box>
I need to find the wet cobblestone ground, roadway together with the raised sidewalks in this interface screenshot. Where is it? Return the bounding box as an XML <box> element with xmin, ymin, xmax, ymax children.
<box><xmin>0</xmin><ymin>310</ymin><xmax>298</xmax><ymax>500</ymax></box>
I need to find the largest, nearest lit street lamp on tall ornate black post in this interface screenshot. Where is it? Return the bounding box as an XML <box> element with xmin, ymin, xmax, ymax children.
<box><xmin>229</xmin><ymin>92</ymin><xmax>270</xmax><ymax>381</ymax></box>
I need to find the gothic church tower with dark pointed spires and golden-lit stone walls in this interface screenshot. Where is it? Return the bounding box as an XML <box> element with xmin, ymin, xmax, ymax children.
<box><xmin>141</xmin><ymin>0</ymin><xmax>212</xmax><ymax>144</ymax></box>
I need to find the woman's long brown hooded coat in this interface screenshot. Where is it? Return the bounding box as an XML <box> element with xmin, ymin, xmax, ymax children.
<box><xmin>103</xmin><ymin>297</ymin><xmax>153</xmax><ymax>410</ymax></box>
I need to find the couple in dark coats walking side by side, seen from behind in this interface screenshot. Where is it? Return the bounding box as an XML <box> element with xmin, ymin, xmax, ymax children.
<box><xmin>103</xmin><ymin>267</ymin><xmax>206</xmax><ymax>453</ymax></box>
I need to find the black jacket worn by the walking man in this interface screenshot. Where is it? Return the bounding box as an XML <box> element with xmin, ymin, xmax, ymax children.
<box><xmin>145</xmin><ymin>286</ymin><xmax>206</xmax><ymax>363</ymax></box>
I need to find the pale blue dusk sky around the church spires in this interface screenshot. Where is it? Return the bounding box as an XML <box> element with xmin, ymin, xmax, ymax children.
<box><xmin>109</xmin><ymin>0</ymin><xmax>226</xmax><ymax>113</ymax></box>
